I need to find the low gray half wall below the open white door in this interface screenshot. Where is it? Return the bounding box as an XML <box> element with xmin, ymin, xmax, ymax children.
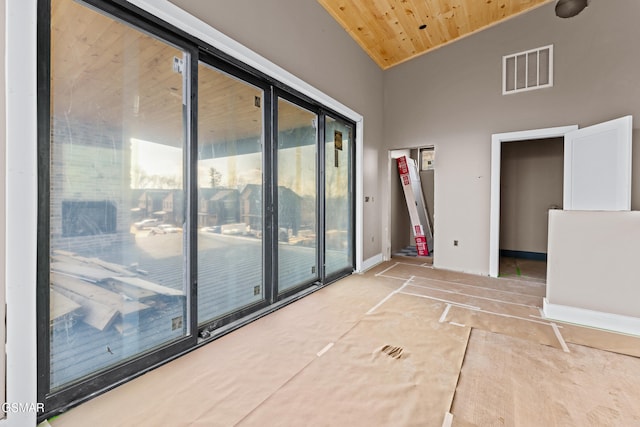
<box><xmin>545</xmin><ymin>211</ymin><xmax>640</xmax><ymax>326</ymax></box>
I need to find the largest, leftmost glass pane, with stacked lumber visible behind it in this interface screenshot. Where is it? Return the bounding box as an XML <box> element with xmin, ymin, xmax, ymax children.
<box><xmin>50</xmin><ymin>0</ymin><xmax>189</xmax><ymax>389</ymax></box>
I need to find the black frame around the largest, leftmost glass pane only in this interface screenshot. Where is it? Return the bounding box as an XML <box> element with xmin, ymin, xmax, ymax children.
<box><xmin>36</xmin><ymin>0</ymin><xmax>198</xmax><ymax>421</ymax></box>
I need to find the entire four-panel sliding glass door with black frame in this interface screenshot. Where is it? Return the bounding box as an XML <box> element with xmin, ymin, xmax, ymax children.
<box><xmin>37</xmin><ymin>0</ymin><xmax>355</xmax><ymax>419</ymax></box>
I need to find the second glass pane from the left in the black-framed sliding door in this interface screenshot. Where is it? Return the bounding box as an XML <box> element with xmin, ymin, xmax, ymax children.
<box><xmin>198</xmin><ymin>63</ymin><xmax>264</xmax><ymax>324</ymax></box>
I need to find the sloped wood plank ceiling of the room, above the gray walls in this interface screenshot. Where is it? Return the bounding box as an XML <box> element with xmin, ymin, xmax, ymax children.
<box><xmin>318</xmin><ymin>0</ymin><xmax>554</xmax><ymax>70</ymax></box>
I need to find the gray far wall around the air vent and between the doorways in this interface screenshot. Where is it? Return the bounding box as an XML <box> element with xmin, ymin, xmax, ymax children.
<box><xmin>381</xmin><ymin>0</ymin><xmax>640</xmax><ymax>274</ymax></box>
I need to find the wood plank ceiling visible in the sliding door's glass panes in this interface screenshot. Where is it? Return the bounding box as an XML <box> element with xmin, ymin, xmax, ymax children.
<box><xmin>51</xmin><ymin>0</ymin><xmax>310</xmax><ymax>147</ymax></box>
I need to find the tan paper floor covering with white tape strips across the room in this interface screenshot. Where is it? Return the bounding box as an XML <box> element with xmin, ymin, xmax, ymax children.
<box><xmin>49</xmin><ymin>257</ymin><xmax>640</xmax><ymax>427</ymax></box>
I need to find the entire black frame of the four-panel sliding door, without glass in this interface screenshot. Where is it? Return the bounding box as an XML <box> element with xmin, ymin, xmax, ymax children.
<box><xmin>36</xmin><ymin>0</ymin><xmax>357</xmax><ymax>422</ymax></box>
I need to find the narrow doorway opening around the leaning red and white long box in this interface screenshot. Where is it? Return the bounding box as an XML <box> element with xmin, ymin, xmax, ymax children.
<box><xmin>387</xmin><ymin>149</ymin><xmax>435</xmax><ymax>263</ymax></box>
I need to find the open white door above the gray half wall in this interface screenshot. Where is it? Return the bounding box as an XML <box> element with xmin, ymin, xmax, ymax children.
<box><xmin>563</xmin><ymin>116</ymin><xmax>633</xmax><ymax>211</ymax></box>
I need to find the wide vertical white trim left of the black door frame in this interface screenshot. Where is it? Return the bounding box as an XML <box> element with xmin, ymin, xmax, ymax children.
<box><xmin>0</xmin><ymin>0</ymin><xmax>38</xmax><ymax>427</ymax></box>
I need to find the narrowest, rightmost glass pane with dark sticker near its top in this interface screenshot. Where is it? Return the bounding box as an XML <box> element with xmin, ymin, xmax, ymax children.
<box><xmin>325</xmin><ymin>116</ymin><xmax>353</xmax><ymax>276</ymax></box>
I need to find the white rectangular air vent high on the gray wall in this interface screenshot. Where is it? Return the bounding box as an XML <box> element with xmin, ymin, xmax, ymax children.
<box><xmin>502</xmin><ymin>45</ymin><xmax>553</xmax><ymax>95</ymax></box>
